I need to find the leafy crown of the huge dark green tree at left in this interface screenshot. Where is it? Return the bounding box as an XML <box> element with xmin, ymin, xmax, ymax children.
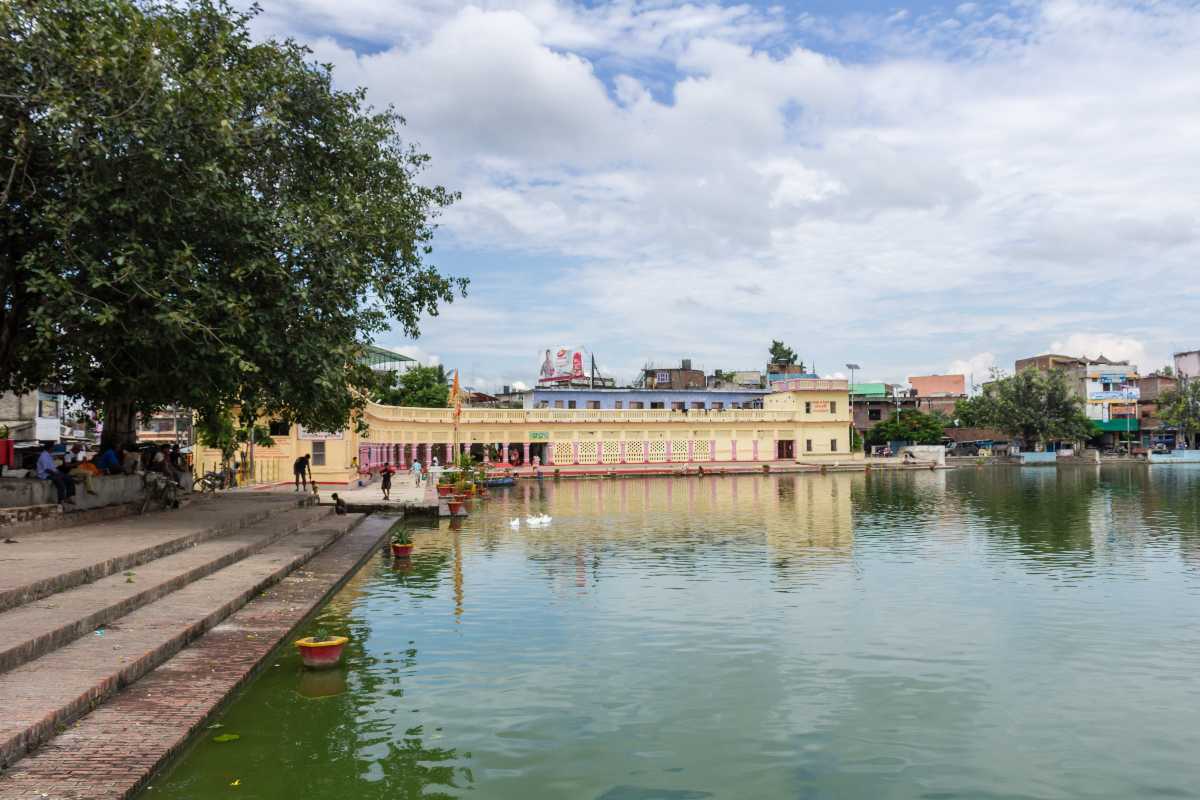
<box><xmin>0</xmin><ymin>0</ymin><xmax>466</xmax><ymax>443</ymax></box>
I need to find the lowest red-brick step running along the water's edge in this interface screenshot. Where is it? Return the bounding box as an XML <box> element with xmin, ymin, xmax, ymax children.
<box><xmin>0</xmin><ymin>517</ymin><xmax>389</xmax><ymax>800</ymax></box>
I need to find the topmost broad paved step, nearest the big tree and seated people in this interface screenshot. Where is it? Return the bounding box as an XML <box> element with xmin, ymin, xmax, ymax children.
<box><xmin>0</xmin><ymin>495</ymin><xmax>312</xmax><ymax>612</ymax></box>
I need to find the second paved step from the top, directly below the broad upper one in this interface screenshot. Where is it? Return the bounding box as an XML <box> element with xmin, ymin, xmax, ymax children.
<box><xmin>0</xmin><ymin>507</ymin><xmax>330</xmax><ymax>673</ymax></box>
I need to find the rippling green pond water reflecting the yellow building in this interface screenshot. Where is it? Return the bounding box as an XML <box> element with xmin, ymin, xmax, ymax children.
<box><xmin>144</xmin><ymin>467</ymin><xmax>1200</xmax><ymax>800</ymax></box>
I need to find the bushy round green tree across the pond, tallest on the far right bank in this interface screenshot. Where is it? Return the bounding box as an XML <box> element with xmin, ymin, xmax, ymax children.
<box><xmin>969</xmin><ymin>369</ymin><xmax>1093</xmax><ymax>447</ymax></box>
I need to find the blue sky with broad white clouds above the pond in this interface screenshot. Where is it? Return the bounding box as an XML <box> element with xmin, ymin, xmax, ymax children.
<box><xmin>246</xmin><ymin>0</ymin><xmax>1200</xmax><ymax>390</ymax></box>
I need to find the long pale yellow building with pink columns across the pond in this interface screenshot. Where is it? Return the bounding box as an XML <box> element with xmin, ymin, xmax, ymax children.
<box><xmin>198</xmin><ymin>378</ymin><xmax>862</xmax><ymax>483</ymax></box>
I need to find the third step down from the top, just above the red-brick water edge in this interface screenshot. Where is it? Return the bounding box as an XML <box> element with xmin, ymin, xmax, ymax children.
<box><xmin>0</xmin><ymin>515</ymin><xmax>361</xmax><ymax>769</ymax></box>
